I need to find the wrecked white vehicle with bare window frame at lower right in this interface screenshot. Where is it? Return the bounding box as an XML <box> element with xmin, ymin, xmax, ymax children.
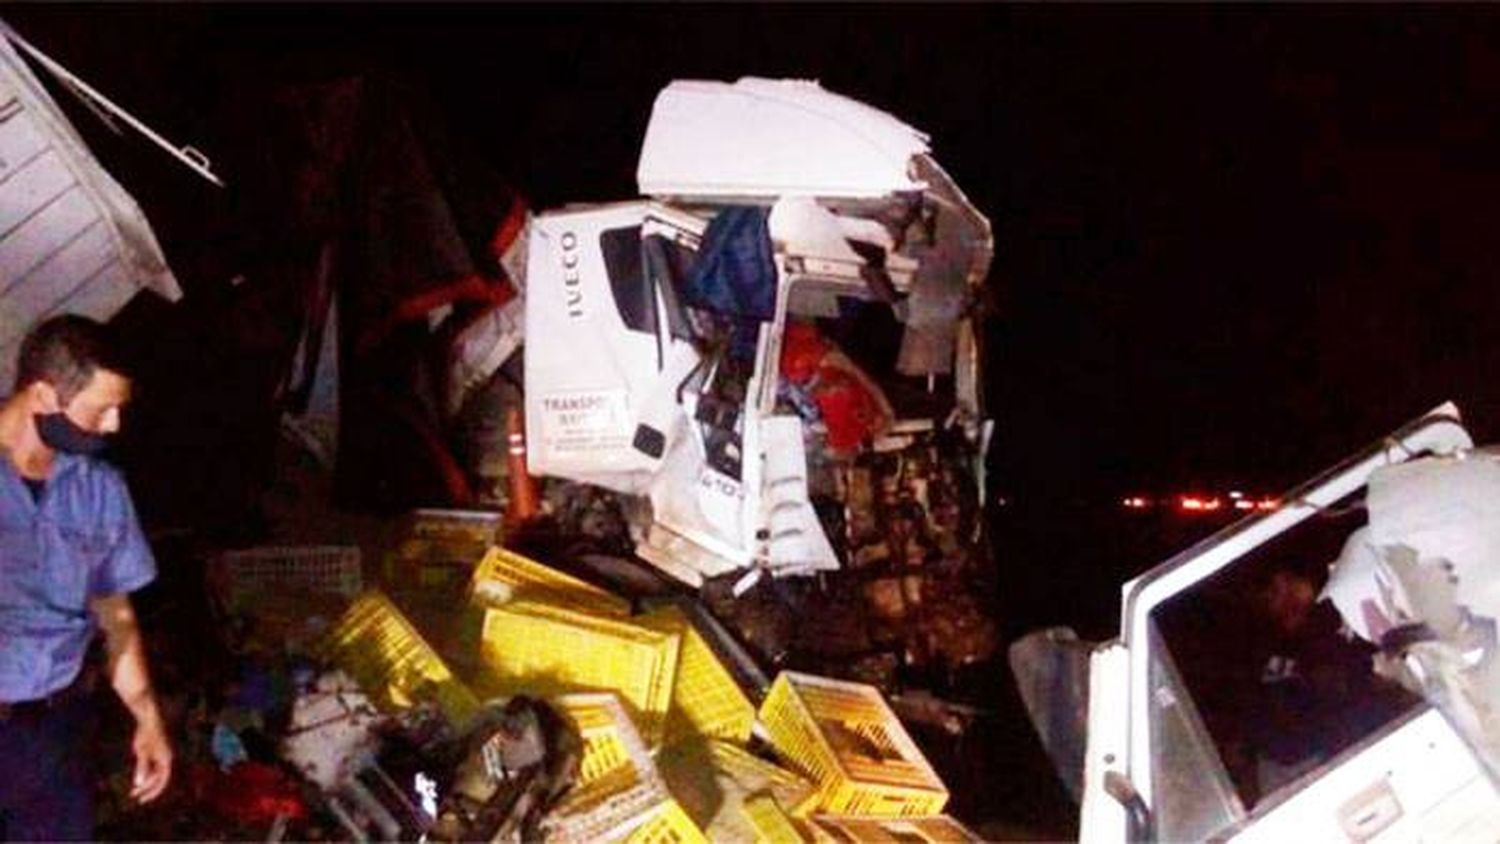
<box><xmin>1013</xmin><ymin>403</ymin><xmax>1500</xmax><ymax>843</ymax></box>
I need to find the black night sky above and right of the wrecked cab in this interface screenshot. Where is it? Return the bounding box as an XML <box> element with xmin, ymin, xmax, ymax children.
<box><xmin>6</xmin><ymin>4</ymin><xmax>1500</xmax><ymax>501</ymax></box>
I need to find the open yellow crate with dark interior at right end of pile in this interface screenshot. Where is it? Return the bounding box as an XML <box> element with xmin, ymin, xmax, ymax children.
<box><xmin>761</xmin><ymin>672</ymin><xmax>948</xmax><ymax>817</ymax></box>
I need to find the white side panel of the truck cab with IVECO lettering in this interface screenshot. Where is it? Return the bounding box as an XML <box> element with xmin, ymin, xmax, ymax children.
<box><xmin>525</xmin><ymin>201</ymin><xmax>707</xmax><ymax>493</ymax></box>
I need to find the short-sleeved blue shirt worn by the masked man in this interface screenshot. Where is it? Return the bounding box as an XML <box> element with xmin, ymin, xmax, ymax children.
<box><xmin>0</xmin><ymin>451</ymin><xmax>156</xmax><ymax>703</ymax></box>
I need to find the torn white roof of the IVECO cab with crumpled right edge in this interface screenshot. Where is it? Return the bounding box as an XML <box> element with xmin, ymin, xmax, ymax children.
<box><xmin>636</xmin><ymin>78</ymin><xmax>995</xmax><ymax>438</ymax></box>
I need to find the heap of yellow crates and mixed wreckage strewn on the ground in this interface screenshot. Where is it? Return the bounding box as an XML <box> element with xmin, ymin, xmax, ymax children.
<box><xmin>111</xmin><ymin>530</ymin><xmax>974</xmax><ymax>843</ymax></box>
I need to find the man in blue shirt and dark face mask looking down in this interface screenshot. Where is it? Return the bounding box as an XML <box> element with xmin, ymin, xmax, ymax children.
<box><xmin>0</xmin><ymin>315</ymin><xmax>173</xmax><ymax>841</ymax></box>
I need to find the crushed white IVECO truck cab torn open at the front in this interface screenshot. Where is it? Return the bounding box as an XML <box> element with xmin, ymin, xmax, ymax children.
<box><xmin>525</xmin><ymin>78</ymin><xmax>993</xmax><ymax>585</ymax></box>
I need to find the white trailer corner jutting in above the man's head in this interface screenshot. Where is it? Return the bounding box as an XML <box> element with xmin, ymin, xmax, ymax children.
<box><xmin>0</xmin><ymin>24</ymin><xmax>182</xmax><ymax>384</ymax></box>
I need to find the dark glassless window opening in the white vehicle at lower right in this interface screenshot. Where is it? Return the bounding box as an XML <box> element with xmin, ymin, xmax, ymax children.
<box><xmin>1157</xmin><ymin>499</ymin><xmax>1419</xmax><ymax>810</ymax></box>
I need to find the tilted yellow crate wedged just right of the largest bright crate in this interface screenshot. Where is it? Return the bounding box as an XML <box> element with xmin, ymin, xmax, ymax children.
<box><xmin>639</xmin><ymin>607</ymin><xmax>755</xmax><ymax>744</ymax></box>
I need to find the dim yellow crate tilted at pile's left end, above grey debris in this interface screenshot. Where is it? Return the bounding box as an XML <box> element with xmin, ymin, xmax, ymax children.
<box><xmin>321</xmin><ymin>591</ymin><xmax>479</xmax><ymax>726</ymax></box>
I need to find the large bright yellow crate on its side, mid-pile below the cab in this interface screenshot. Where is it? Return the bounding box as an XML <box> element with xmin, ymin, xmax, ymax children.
<box><xmin>476</xmin><ymin>601</ymin><xmax>681</xmax><ymax>745</ymax></box>
